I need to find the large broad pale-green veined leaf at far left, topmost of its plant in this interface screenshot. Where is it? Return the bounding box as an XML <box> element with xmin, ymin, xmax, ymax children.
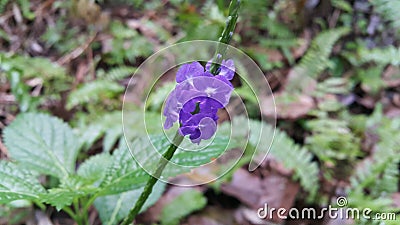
<box><xmin>4</xmin><ymin>113</ymin><xmax>79</xmax><ymax>178</ymax></box>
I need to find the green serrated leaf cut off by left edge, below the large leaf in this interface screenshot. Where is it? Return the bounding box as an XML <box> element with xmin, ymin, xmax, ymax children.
<box><xmin>0</xmin><ymin>161</ymin><xmax>45</xmax><ymax>204</ymax></box>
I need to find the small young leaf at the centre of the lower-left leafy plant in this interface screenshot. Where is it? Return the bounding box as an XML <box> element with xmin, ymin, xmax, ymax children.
<box><xmin>77</xmin><ymin>153</ymin><xmax>112</xmax><ymax>184</ymax></box>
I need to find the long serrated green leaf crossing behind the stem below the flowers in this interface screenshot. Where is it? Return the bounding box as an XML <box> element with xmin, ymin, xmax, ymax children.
<box><xmin>100</xmin><ymin>135</ymin><xmax>233</xmax><ymax>195</ymax></box>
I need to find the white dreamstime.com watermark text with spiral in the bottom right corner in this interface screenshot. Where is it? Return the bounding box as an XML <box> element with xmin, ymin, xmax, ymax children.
<box><xmin>257</xmin><ymin>196</ymin><xmax>396</xmax><ymax>220</ymax></box>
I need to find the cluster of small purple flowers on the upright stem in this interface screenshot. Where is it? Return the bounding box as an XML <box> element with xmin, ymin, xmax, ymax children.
<box><xmin>164</xmin><ymin>60</ymin><xmax>235</xmax><ymax>144</ymax></box>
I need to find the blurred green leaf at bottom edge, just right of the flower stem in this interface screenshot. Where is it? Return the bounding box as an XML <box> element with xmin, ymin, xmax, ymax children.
<box><xmin>161</xmin><ymin>189</ymin><xmax>207</xmax><ymax>225</ymax></box>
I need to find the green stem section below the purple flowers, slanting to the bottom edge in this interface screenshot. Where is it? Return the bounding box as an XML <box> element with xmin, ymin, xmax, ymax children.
<box><xmin>122</xmin><ymin>132</ymin><xmax>183</xmax><ymax>225</ymax></box>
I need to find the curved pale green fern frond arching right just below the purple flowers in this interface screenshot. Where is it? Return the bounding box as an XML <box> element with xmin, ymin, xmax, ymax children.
<box><xmin>220</xmin><ymin>117</ymin><xmax>319</xmax><ymax>194</ymax></box>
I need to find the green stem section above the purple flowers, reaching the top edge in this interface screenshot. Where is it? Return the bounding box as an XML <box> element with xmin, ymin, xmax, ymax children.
<box><xmin>210</xmin><ymin>0</ymin><xmax>241</xmax><ymax>75</ymax></box>
